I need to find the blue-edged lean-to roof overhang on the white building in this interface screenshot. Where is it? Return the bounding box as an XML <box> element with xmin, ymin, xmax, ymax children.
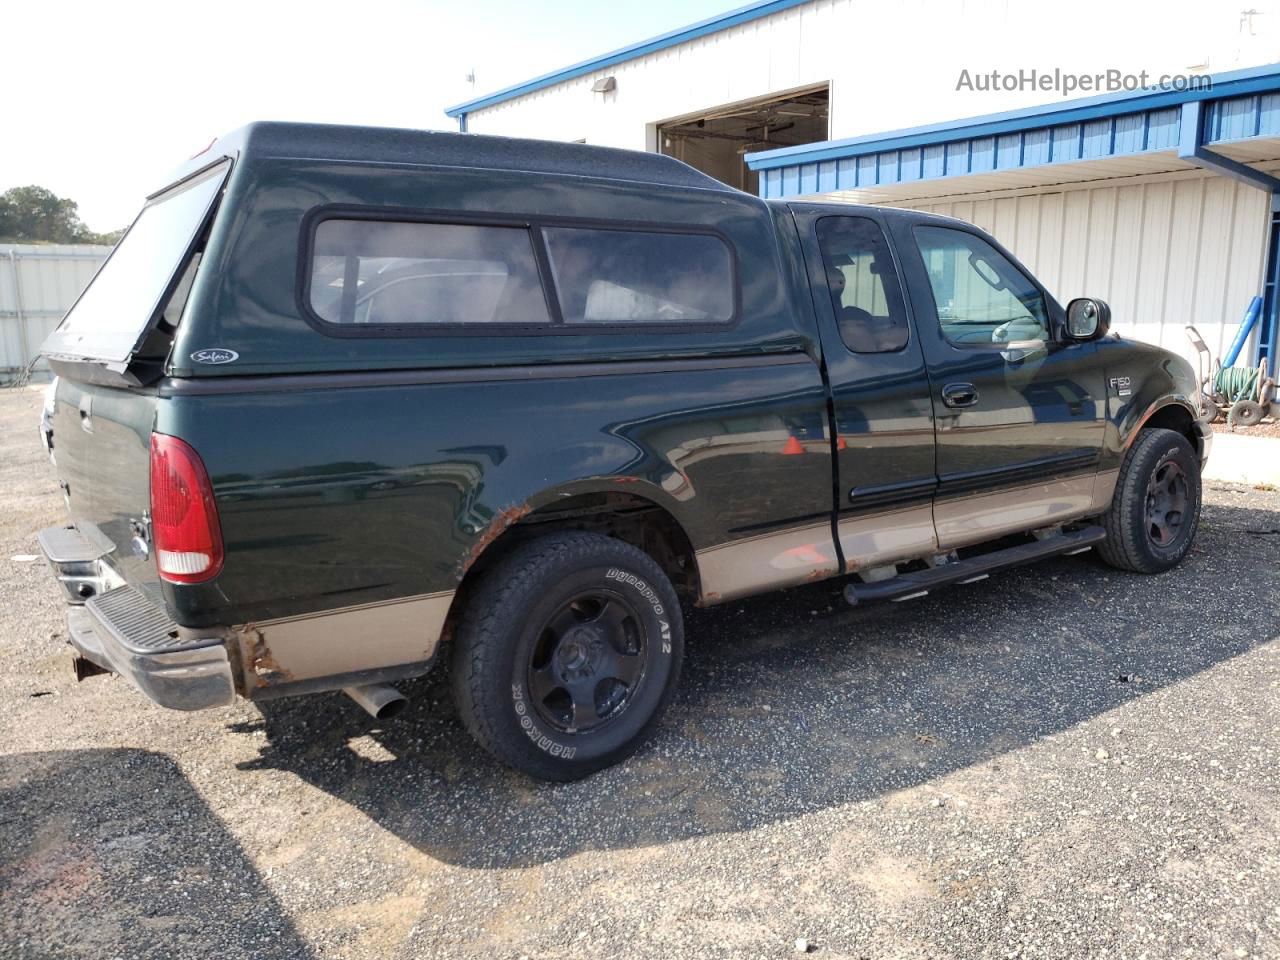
<box><xmin>746</xmin><ymin>64</ymin><xmax>1280</xmax><ymax>202</ymax></box>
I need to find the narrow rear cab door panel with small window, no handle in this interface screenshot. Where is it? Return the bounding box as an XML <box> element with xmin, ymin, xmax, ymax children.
<box><xmin>792</xmin><ymin>204</ymin><xmax>937</xmax><ymax>572</ymax></box>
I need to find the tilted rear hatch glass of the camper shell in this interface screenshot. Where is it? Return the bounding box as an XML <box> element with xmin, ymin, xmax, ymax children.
<box><xmin>42</xmin><ymin>163</ymin><xmax>230</xmax><ymax>362</ymax></box>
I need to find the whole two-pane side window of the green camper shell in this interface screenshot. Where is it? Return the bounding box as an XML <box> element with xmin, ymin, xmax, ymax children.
<box><xmin>300</xmin><ymin>210</ymin><xmax>739</xmax><ymax>335</ymax></box>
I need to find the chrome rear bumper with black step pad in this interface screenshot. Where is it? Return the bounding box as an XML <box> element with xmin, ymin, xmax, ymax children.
<box><xmin>40</xmin><ymin>527</ymin><xmax>236</xmax><ymax>710</ymax></box>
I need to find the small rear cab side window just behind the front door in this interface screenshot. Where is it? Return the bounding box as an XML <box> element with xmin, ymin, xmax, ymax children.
<box><xmin>818</xmin><ymin>216</ymin><xmax>909</xmax><ymax>353</ymax></box>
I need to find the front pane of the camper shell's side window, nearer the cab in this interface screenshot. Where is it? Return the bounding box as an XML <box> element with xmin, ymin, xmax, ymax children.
<box><xmin>543</xmin><ymin>227</ymin><xmax>736</xmax><ymax>324</ymax></box>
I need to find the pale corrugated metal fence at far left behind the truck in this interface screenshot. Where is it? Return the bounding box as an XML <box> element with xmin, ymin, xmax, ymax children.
<box><xmin>0</xmin><ymin>243</ymin><xmax>111</xmax><ymax>375</ymax></box>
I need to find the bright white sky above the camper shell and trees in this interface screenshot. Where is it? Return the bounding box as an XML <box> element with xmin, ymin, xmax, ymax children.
<box><xmin>0</xmin><ymin>0</ymin><xmax>745</xmax><ymax>232</ymax></box>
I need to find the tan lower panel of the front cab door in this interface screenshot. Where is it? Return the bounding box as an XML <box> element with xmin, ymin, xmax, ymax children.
<box><xmin>933</xmin><ymin>474</ymin><xmax>1094</xmax><ymax>550</ymax></box>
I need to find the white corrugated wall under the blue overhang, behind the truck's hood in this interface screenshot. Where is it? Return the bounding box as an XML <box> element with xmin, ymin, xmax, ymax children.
<box><xmin>901</xmin><ymin>173</ymin><xmax>1268</xmax><ymax>358</ymax></box>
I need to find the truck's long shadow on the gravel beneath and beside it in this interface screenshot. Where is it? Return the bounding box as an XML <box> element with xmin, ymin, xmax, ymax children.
<box><xmin>238</xmin><ymin>496</ymin><xmax>1280</xmax><ymax>868</ymax></box>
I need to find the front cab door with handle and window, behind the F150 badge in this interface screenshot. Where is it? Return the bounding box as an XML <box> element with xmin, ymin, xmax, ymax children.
<box><xmin>893</xmin><ymin>216</ymin><xmax>1106</xmax><ymax>549</ymax></box>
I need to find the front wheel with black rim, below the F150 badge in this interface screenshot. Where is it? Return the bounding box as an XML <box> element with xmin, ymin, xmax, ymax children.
<box><xmin>1098</xmin><ymin>429</ymin><xmax>1201</xmax><ymax>573</ymax></box>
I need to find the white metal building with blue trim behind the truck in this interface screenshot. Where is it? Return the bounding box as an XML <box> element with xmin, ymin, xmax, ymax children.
<box><xmin>447</xmin><ymin>0</ymin><xmax>1280</xmax><ymax>370</ymax></box>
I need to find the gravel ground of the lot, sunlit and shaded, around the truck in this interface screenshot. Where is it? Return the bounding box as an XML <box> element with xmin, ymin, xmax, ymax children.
<box><xmin>0</xmin><ymin>390</ymin><xmax>1280</xmax><ymax>960</ymax></box>
